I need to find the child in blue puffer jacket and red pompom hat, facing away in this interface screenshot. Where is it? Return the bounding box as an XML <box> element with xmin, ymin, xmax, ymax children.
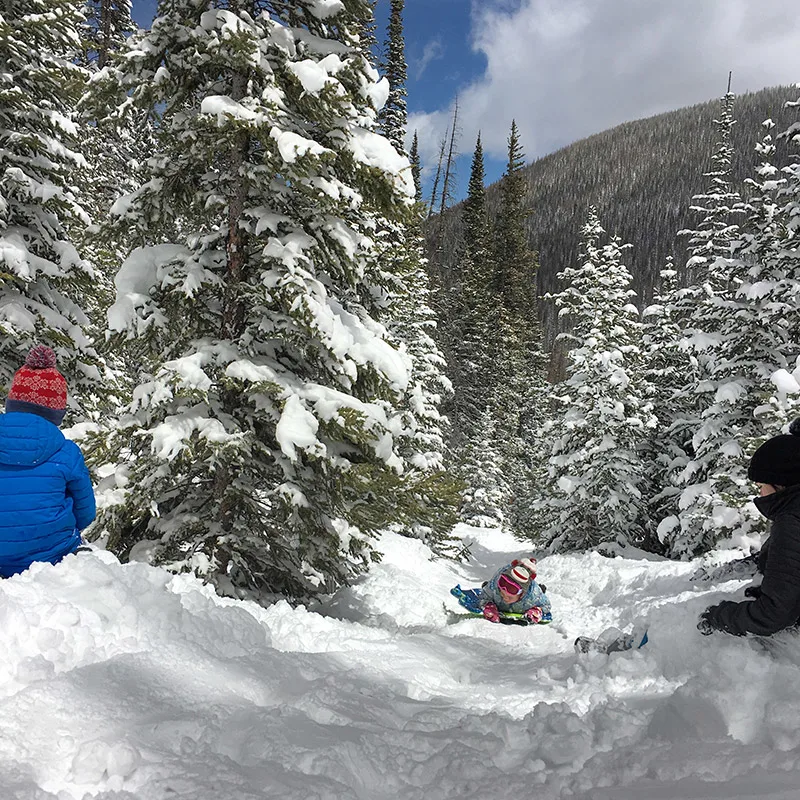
<box><xmin>0</xmin><ymin>345</ymin><xmax>95</xmax><ymax>578</ymax></box>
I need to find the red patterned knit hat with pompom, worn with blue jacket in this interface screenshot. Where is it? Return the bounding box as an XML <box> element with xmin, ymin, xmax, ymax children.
<box><xmin>6</xmin><ymin>344</ymin><xmax>67</xmax><ymax>425</ymax></box>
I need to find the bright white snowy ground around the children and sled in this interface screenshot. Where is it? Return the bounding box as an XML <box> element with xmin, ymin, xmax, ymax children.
<box><xmin>0</xmin><ymin>530</ymin><xmax>800</xmax><ymax>800</ymax></box>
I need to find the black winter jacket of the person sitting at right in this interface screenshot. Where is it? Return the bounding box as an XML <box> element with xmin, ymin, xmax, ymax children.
<box><xmin>704</xmin><ymin>485</ymin><xmax>800</xmax><ymax>636</ymax></box>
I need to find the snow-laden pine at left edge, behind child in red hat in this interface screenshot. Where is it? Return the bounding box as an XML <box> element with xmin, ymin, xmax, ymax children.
<box><xmin>0</xmin><ymin>0</ymin><xmax>100</xmax><ymax>418</ymax></box>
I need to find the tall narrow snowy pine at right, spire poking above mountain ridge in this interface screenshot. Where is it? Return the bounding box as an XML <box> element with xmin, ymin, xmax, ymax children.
<box><xmin>659</xmin><ymin>84</ymin><xmax>752</xmax><ymax>556</ymax></box>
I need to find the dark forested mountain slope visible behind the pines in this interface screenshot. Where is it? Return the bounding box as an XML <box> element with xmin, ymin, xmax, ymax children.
<box><xmin>427</xmin><ymin>87</ymin><xmax>797</xmax><ymax>348</ymax></box>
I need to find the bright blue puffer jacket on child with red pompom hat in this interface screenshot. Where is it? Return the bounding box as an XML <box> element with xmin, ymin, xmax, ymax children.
<box><xmin>0</xmin><ymin>412</ymin><xmax>95</xmax><ymax>578</ymax></box>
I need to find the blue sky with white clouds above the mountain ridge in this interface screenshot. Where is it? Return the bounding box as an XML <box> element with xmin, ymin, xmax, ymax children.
<box><xmin>128</xmin><ymin>0</ymin><xmax>800</xmax><ymax>203</ymax></box>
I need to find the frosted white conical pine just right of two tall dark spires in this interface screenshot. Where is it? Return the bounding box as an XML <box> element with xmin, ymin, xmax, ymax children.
<box><xmin>537</xmin><ymin>208</ymin><xmax>656</xmax><ymax>551</ymax></box>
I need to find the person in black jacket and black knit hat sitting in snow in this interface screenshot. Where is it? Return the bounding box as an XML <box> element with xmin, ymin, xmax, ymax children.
<box><xmin>697</xmin><ymin>419</ymin><xmax>800</xmax><ymax>636</ymax></box>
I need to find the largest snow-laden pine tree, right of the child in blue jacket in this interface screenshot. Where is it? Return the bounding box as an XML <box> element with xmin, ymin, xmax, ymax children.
<box><xmin>92</xmin><ymin>0</ymin><xmax>456</xmax><ymax>598</ymax></box>
